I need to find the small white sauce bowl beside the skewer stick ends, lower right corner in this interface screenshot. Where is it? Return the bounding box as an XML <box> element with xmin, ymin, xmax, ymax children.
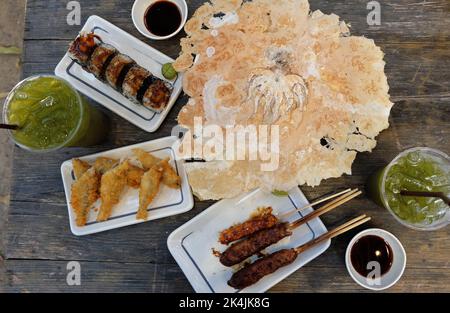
<box><xmin>345</xmin><ymin>228</ymin><xmax>406</xmax><ymax>291</ymax></box>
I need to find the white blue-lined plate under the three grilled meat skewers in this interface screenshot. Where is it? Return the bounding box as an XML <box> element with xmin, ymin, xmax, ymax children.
<box><xmin>167</xmin><ymin>188</ymin><xmax>331</xmax><ymax>293</ymax></box>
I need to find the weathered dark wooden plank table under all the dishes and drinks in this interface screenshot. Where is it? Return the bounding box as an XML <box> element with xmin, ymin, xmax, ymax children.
<box><xmin>0</xmin><ymin>0</ymin><xmax>450</xmax><ymax>292</ymax></box>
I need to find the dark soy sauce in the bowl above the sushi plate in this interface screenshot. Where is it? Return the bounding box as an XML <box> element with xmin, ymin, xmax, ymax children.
<box><xmin>144</xmin><ymin>1</ymin><xmax>182</xmax><ymax>37</ymax></box>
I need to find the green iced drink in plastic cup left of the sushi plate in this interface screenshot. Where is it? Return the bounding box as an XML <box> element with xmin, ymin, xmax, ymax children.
<box><xmin>3</xmin><ymin>75</ymin><xmax>109</xmax><ymax>152</ymax></box>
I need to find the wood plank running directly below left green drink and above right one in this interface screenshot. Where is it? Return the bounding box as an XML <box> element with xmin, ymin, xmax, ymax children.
<box><xmin>7</xmin><ymin>98</ymin><xmax>450</xmax><ymax>204</ymax></box>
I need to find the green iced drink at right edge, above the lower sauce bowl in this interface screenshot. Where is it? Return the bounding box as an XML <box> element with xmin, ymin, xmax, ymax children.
<box><xmin>367</xmin><ymin>148</ymin><xmax>450</xmax><ymax>230</ymax></box>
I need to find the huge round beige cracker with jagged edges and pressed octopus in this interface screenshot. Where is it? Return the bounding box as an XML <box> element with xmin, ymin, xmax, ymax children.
<box><xmin>174</xmin><ymin>0</ymin><xmax>393</xmax><ymax>199</ymax></box>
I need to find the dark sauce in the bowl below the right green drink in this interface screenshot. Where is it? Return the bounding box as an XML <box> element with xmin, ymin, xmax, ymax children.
<box><xmin>350</xmin><ymin>235</ymin><xmax>394</xmax><ymax>277</ymax></box>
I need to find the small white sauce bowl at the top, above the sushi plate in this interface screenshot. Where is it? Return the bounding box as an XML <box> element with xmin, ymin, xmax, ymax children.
<box><xmin>131</xmin><ymin>0</ymin><xmax>189</xmax><ymax>40</ymax></box>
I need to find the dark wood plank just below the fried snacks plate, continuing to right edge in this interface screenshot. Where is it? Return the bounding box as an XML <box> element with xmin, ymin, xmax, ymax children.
<box><xmin>5</xmin><ymin>197</ymin><xmax>450</xmax><ymax>269</ymax></box>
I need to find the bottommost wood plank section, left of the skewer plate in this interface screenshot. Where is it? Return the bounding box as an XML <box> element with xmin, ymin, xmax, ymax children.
<box><xmin>0</xmin><ymin>260</ymin><xmax>193</xmax><ymax>293</ymax></box>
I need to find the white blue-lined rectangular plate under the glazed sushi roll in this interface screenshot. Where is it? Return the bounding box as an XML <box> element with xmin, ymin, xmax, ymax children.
<box><xmin>55</xmin><ymin>15</ymin><xmax>182</xmax><ymax>133</ymax></box>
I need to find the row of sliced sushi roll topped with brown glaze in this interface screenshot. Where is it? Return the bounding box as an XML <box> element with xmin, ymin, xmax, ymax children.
<box><xmin>69</xmin><ymin>34</ymin><xmax>172</xmax><ymax>113</ymax></box>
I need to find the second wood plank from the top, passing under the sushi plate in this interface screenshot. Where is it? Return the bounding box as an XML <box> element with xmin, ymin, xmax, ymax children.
<box><xmin>24</xmin><ymin>40</ymin><xmax>450</xmax><ymax>99</ymax></box>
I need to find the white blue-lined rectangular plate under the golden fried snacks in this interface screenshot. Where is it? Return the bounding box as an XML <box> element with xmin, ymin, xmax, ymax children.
<box><xmin>61</xmin><ymin>137</ymin><xmax>194</xmax><ymax>236</ymax></box>
